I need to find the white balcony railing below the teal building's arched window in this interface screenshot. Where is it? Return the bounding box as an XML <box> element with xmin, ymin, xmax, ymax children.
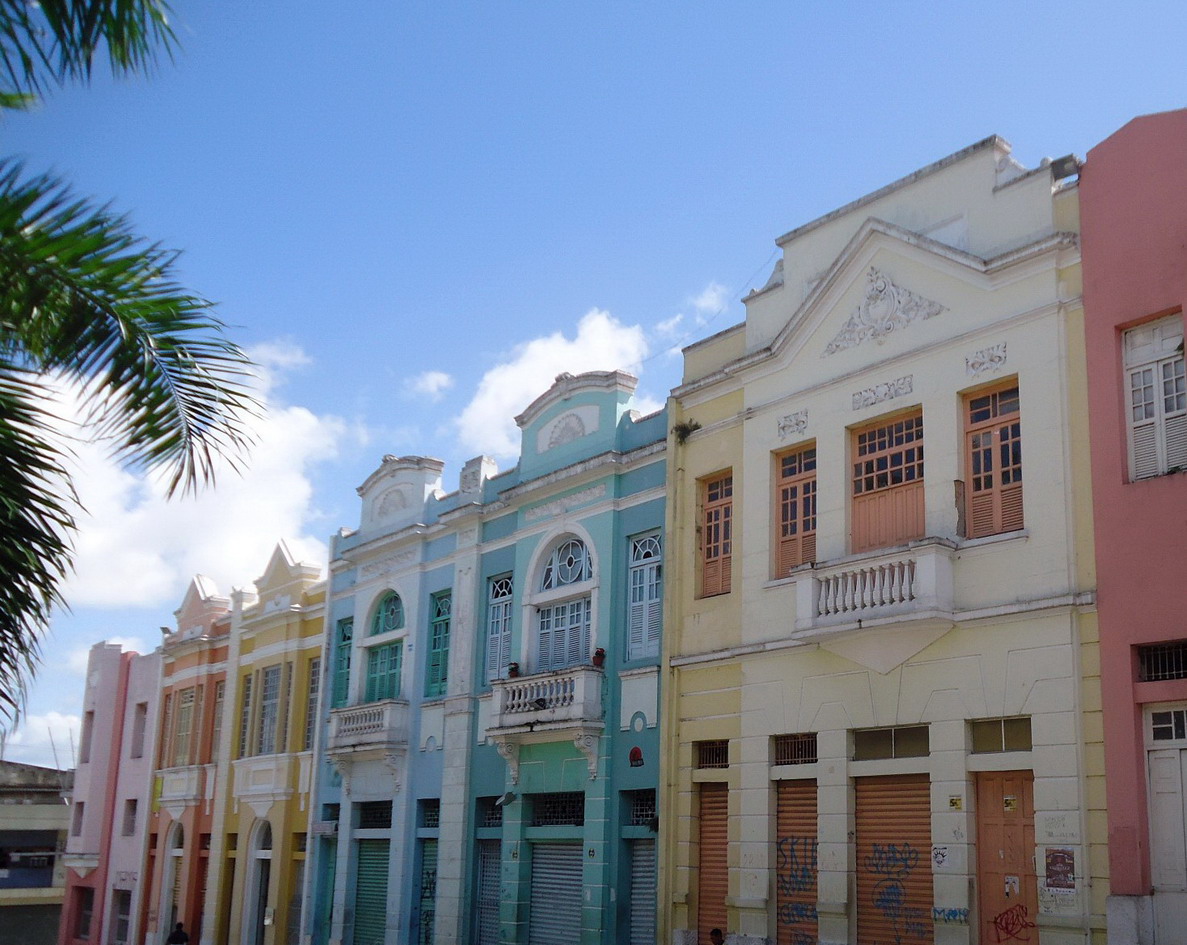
<box><xmin>488</xmin><ymin>666</ymin><xmax>604</xmax><ymax>735</ymax></box>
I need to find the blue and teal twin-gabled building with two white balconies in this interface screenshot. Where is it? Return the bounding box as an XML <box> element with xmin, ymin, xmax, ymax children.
<box><xmin>305</xmin><ymin>372</ymin><xmax>667</xmax><ymax>945</ymax></box>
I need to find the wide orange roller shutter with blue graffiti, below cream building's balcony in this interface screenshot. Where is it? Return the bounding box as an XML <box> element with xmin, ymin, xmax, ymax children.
<box><xmin>855</xmin><ymin>774</ymin><xmax>935</xmax><ymax>945</ymax></box>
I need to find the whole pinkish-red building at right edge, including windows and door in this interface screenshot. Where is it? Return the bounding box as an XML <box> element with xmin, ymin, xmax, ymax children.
<box><xmin>1080</xmin><ymin>109</ymin><xmax>1187</xmax><ymax>945</ymax></box>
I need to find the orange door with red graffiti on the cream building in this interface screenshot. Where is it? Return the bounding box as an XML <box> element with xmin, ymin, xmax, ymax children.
<box><xmin>977</xmin><ymin>772</ymin><xmax>1039</xmax><ymax>945</ymax></box>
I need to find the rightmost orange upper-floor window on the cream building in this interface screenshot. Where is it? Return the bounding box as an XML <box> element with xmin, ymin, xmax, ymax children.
<box><xmin>964</xmin><ymin>380</ymin><xmax>1023</xmax><ymax>538</ymax></box>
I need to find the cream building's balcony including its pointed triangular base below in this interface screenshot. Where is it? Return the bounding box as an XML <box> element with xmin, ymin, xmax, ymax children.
<box><xmin>792</xmin><ymin>538</ymin><xmax>956</xmax><ymax>672</ymax></box>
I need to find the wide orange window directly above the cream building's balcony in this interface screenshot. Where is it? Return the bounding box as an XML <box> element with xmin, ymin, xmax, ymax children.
<box><xmin>850</xmin><ymin>410</ymin><xmax>926</xmax><ymax>553</ymax></box>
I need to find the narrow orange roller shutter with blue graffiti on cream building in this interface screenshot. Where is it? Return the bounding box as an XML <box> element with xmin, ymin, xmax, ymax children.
<box><xmin>775</xmin><ymin>781</ymin><xmax>818</xmax><ymax>945</ymax></box>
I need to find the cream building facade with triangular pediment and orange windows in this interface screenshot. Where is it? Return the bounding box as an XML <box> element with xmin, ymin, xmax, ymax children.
<box><xmin>660</xmin><ymin>137</ymin><xmax>1107</xmax><ymax>945</ymax></box>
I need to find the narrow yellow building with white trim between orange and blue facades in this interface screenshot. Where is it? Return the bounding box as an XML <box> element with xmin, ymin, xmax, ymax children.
<box><xmin>203</xmin><ymin>543</ymin><xmax>325</xmax><ymax>945</ymax></box>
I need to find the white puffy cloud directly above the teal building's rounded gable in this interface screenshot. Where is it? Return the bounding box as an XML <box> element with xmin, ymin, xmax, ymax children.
<box><xmin>457</xmin><ymin>309</ymin><xmax>647</xmax><ymax>457</ymax></box>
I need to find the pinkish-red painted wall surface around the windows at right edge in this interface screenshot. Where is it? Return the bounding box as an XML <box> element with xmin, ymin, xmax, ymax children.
<box><xmin>1079</xmin><ymin>109</ymin><xmax>1187</xmax><ymax>895</ymax></box>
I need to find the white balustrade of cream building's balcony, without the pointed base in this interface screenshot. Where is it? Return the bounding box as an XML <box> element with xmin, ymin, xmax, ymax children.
<box><xmin>793</xmin><ymin>538</ymin><xmax>954</xmax><ymax>633</ymax></box>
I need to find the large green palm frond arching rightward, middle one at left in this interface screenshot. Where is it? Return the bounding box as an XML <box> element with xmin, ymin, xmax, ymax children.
<box><xmin>0</xmin><ymin>160</ymin><xmax>259</xmax><ymax>494</ymax></box>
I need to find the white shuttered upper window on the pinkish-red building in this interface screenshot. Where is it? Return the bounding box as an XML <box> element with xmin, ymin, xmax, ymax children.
<box><xmin>1122</xmin><ymin>312</ymin><xmax>1187</xmax><ymax>480</ymax></box>
